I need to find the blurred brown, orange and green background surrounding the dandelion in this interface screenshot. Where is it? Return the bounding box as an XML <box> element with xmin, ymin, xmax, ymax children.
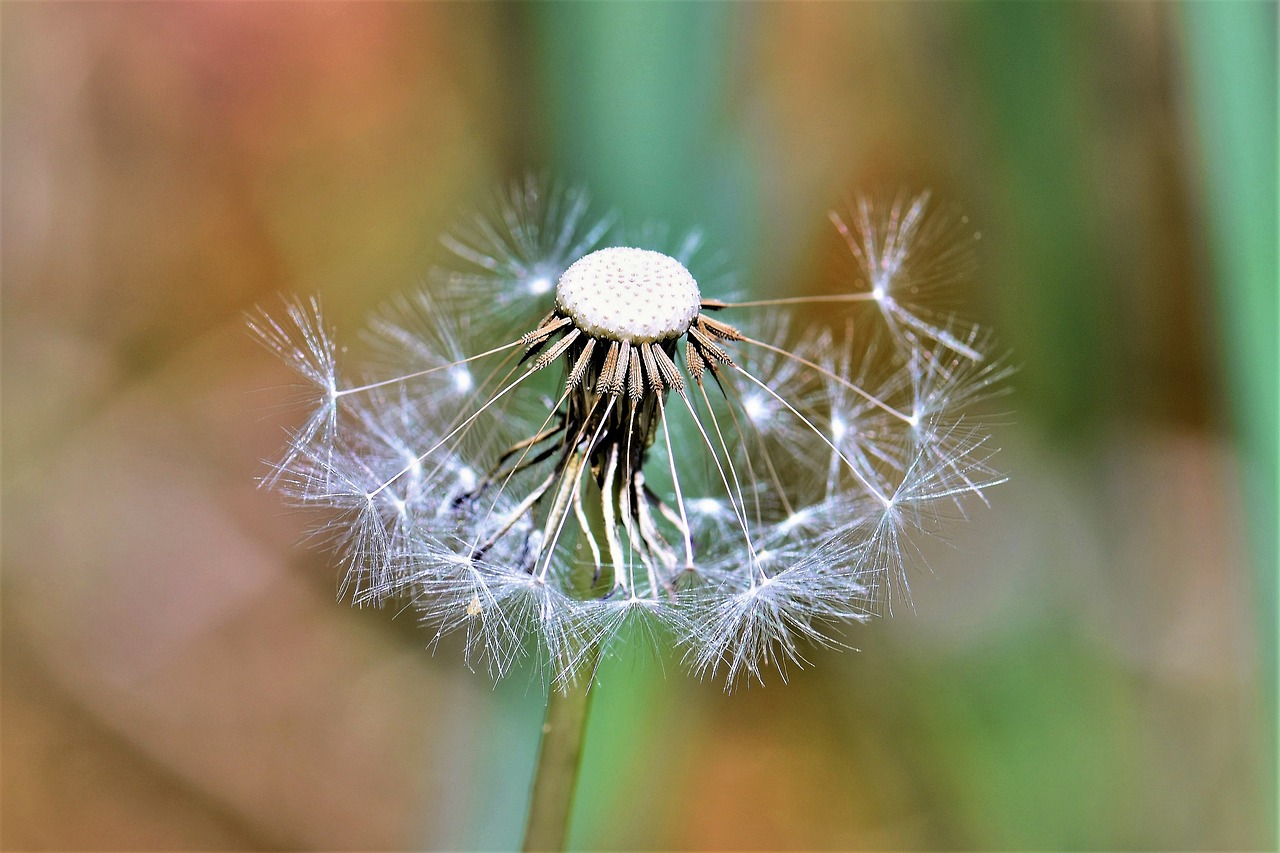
<box><xmin>0</xmin><ymin>3</ymin><xmax>1277</xmax><ymax>850</ymax></box>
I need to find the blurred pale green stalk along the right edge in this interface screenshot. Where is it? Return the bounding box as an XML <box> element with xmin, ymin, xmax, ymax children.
<box><xmin>1181</xmin><ymin>3</ymin><xmax>1280</xmax><ymax>839</ymax></box>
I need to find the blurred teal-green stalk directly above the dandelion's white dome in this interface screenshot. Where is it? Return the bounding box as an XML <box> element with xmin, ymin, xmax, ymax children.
<box><xmin>530</xmin><ymin>0</ymin><xmax>756</xmax><ymax>262</ymax></box>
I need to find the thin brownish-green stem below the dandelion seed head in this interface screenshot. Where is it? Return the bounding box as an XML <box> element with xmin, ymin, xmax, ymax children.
<box><xmin>524</xmin><ymin>646</ymin><xmax>600</xmax><ymax>850</ymax></box>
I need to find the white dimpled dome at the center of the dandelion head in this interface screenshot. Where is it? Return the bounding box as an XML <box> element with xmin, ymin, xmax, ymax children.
<box><xmin>556</xmin><ymin>246</ymin><xmax>703</xmax><ymax>343</ymax></box>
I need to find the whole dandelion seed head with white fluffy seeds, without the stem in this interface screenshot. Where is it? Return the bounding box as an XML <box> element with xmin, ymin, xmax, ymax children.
<box><xmin>251</xmin><ymin>181</ymin><xmax>1005</xmax><ymax>684</ymax></box>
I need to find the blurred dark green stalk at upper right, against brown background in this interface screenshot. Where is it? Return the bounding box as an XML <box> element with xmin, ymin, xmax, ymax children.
<box><xmin>948</xmin><ymin>3</ymin><xmax>1123</xmax><ymax>446</ymax></box>
